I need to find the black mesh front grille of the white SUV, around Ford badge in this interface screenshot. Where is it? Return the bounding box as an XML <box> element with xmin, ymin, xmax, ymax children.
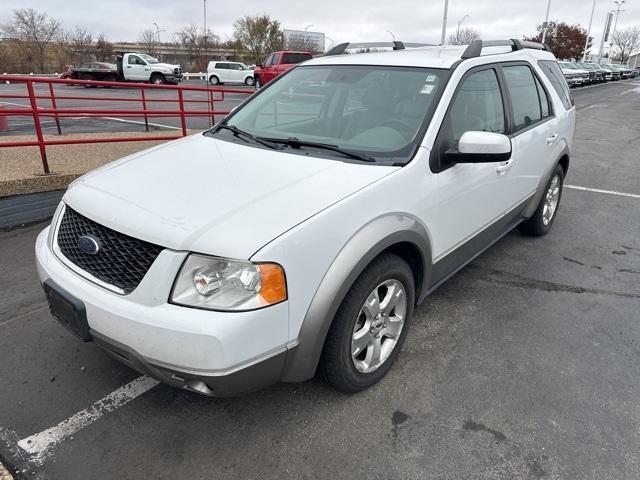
<box><xmin>57</xmin><ymin>207</ymin><xmax>162</xmax><ymax>293</ymax></box>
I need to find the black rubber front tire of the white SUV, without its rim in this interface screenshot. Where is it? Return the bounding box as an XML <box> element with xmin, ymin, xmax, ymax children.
<box><xmin>323</xmin><ymin>254</ymin><xmax>415</xmax><ymax>393</ymax></box>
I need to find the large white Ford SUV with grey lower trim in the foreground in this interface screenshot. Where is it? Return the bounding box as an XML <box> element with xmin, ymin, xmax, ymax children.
<box><xmin>36</xmin><ymin>40</ymin><xmax>575</xmax><ymax>396</ymax></box>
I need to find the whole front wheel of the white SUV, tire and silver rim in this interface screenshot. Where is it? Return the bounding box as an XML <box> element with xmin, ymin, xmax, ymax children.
<box><xmin>319</xmin><ymin>253</ymin><xmax>415</xmax><ymax>393</ymax></box>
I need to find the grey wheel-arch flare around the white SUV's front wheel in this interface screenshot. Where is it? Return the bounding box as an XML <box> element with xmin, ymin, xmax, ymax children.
<box><xmin>282</xmin><ymin>213</ymin><xmax>432</xmax><ymax>382</ymax></box>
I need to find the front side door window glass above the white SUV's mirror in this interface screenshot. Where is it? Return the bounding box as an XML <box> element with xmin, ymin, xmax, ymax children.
<box><xmin>449</xmin><ymin>70</ymin><xmax>505</xmax><ymax>145</ymax></box>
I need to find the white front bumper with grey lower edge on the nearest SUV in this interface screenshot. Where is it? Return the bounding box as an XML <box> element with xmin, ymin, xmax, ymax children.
<box><xmin>36</xmin><ymin>227</ymin><xmax>295</xmax><ymax>396</ymax></box>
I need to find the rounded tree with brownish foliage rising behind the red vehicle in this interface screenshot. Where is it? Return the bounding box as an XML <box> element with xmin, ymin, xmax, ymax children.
<box><xmin>233</xmin><ymin>14</ymin><xmax>282</xmax><ymax>63</ymax></box>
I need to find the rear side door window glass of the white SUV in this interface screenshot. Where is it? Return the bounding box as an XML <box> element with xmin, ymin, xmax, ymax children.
<box><xmin>502</xmin><ymin>65</ymin><xmax>542</xmax><ymax>131</ymax></box>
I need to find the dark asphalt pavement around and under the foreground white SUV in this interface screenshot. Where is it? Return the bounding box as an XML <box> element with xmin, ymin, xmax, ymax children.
<box><xmin>0</xmin><ymin>80</ymin><xmax>640</xmax><ymax>480</ymax></box>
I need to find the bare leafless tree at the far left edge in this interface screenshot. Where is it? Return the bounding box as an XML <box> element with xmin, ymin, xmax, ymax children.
<box><xmin>1</xmin><ymin>8</ymin><xmax>63</xmax><ymax>72</ymax></box>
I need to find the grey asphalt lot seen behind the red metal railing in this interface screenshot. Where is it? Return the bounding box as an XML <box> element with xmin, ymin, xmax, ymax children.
<box><xmin>0</xmin><ymin>80</ymin><xmax>255</xmax><ymax>138</ymax></box>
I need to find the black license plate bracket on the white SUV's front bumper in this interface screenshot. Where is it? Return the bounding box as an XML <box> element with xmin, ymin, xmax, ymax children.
<box><xmin>42</xmin><ymin>279</ymin><xmax>92</xmax><ymax>342</ymax></box>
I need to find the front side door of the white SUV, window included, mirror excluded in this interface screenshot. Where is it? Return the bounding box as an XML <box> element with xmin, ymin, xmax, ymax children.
<box><xmin>429</xmin><ymin>66</ymin><xmax>525</xmax><ymax>272</ymax></box>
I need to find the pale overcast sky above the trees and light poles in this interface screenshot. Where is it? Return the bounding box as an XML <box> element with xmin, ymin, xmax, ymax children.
<box><xmin>0</xmin><ymin>0</ymin><xmax>640</xmax><ymax>47</ymax></box>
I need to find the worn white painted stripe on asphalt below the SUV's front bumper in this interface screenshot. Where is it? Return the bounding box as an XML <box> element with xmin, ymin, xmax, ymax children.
<box><xmin>18</xmin><ymin>375</ymin><xmax>160</xmax><ymax>465</ymax></box>
